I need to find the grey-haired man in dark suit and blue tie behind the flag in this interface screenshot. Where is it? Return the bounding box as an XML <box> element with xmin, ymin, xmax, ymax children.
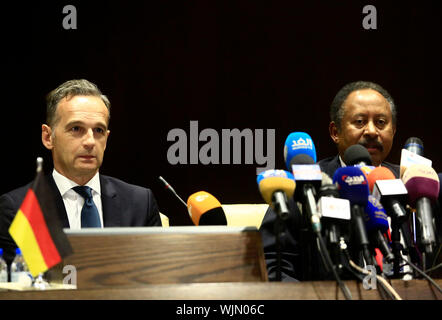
<box><xmin>0</xmin><ymin>80</ymin><xmax>161</xmax><ymax>263</ymax></box>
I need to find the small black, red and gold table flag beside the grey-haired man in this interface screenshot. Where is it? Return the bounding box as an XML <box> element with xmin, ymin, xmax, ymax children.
<box><xmin>9</xmin><ymin>161</ymin><xmax>72</xmax><ymax>277</ymax></box>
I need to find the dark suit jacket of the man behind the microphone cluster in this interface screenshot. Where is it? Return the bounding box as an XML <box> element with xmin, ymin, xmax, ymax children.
<box><xmin>260</xmin><ymin>156</ymin><xmax>400</xmax><ymax>281</ymax></box>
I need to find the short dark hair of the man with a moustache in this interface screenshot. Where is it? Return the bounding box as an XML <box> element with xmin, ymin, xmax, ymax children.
<box><xmin>330</xmin><ymin>81</ymin><xmax>397</xmax><ymax>130</ymax></box>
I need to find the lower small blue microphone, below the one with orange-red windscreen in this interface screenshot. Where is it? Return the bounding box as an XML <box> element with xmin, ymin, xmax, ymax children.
<box><xmin>365</xmin><ymin>195</ymin><xmax>394</xmax><ymax>262</ymax></box>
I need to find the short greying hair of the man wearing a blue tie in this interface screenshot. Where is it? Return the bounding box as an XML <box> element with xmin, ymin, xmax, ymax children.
<box><xmin>46</xmin><ymin>79</ymin><xmax>110</xmax><ymax>127</ymax></box>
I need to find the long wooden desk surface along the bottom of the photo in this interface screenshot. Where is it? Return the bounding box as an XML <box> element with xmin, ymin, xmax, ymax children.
<box><xmin>0</xmin><ymin>279</ymin><xmax>442</xmax><ymax>300</ymax></box>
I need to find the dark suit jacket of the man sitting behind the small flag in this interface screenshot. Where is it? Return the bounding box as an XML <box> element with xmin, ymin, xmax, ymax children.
<box><xmin>0</xmin><ymin>174</ymin><xmax>161</xmax><ymax>264</ymax></box>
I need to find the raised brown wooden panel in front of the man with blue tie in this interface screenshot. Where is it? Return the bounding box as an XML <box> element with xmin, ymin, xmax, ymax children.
<box><xmin>60</xmin><ymin>228</ymin><xmax>267</xmax><ymax>289</ymax></box>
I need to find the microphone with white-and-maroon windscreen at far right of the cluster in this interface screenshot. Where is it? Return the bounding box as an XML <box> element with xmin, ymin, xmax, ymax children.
<box><xmin>402</xmin><ymin>164</ymin><xmax>440</xmax><ymax>254</ymax></box>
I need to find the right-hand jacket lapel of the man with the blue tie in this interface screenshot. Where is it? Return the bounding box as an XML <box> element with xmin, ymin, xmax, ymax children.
<box><xmin>100</xmin><ymin>174</ymin><xmax>121</xmax><ymax>227</ymax></box>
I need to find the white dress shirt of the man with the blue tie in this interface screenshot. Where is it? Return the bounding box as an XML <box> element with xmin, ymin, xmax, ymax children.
<box><xmin>52</xmin><ymin>169</ymin><xmax>103</xmax><ymax>230</ymax></box>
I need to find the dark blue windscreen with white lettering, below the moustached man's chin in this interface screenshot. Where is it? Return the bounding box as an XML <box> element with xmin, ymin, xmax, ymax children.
<box><xmin>333</xmin><ymin>167</ymin><xmax>370</xmax><ymax>206</ymax></box>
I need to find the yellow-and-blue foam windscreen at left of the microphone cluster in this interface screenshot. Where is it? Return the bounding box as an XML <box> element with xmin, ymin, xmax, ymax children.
<box><xmin>256</xmin><ymin>169</ymin><xmax>296</xmax><ymax>205</ymax></box>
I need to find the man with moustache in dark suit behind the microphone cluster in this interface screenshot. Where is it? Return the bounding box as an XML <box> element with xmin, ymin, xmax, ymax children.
<box><xmin>260</xmin><ymin>81</ymin><xmax>399</xmax><ymax>281</ymax></box>
